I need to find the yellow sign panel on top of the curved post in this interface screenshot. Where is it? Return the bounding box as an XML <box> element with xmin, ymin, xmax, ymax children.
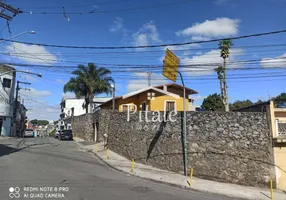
<box><xmin>163</xmin><ymin>49</ymin><xmax>180</xmax><ymax>82</ymax></box>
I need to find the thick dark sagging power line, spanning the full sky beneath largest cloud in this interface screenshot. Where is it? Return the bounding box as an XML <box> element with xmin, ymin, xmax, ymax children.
<box><xmin>0</xmin><ymin>29</ymin><xmax>286</xmax><ymax>49</ymax></box>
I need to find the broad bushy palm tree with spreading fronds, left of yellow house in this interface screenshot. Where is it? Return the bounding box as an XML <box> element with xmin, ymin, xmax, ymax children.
<box><xmin>64</xmin><ymin>63</ymin><xmax>113</xmax><ymax>113</ymax></box>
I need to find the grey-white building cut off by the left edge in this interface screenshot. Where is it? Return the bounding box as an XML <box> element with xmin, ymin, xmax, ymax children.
<box><xmin>0</xmin><ymin>64</ymin><xmax>16</xmax><ymax>136</ymax></box>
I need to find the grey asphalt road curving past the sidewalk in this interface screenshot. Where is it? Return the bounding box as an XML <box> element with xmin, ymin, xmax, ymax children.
<box><xmin>0</xmin><ymin>138</ymin><xmax>233</xmax><ymax>200</ymax></box>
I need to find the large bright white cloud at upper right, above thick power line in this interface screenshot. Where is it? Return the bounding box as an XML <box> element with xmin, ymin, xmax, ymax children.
<box><xmin>176</xmin><ymin>17</ymin><xmax>240</xmax><ymax>37</ymax></box>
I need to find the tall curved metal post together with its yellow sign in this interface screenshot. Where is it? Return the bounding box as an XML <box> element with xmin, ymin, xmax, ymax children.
<box><xmin>162</xmin><ymin>49</ymin><xmax>188</xmax><ymax>176</ymax></box>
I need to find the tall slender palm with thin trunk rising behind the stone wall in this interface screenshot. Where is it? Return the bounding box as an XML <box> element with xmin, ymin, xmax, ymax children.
<box><xmin>217</xmin><ymin>40</ymin><xmax>233</xmax><ymax>112</ymax></box>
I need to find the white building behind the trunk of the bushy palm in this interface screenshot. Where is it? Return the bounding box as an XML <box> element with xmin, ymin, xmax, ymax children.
<box><xmin>58</xmin><ymin>97</ymin><xmax>111</xmax><ymax>130</ymax></box>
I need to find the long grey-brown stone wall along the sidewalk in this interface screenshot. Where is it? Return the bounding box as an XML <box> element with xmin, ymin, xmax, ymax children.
<box><xmin>73</xmin><ymin>110</ymin><xmax>275</xmax><ymax>187</ymax></box>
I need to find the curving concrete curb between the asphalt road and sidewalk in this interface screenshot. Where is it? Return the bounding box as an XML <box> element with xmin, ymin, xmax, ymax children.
<box><xmin>75</xmin><ymin>141</ymin><xmax>249</xmax><ymax>200</ymax></box>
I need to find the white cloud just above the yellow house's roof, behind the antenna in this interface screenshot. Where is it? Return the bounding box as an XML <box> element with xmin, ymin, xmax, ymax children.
<box><xmin>127</xmin><ymin>72</ymin><xmax>170</xmax><ymax>92</ymax></box>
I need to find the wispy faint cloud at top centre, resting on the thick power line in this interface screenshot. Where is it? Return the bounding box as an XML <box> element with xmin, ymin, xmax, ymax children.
<box><xmin>133</xmin><ymin>21</ymin><xmax>161</xmax><ymax>46</ymax></box>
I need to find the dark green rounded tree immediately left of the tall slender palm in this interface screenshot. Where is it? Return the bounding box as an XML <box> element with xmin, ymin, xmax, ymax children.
<box><xmin>201</xmin><ymin>93</ymin><xmax>224</xmax><ymax>111</ymax></box>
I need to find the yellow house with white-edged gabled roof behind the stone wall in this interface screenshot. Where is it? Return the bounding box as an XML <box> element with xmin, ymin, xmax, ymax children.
<box><xmin>100</xmin><ymin>84</ymin><xmax>197</xmax><ymax>112</ymax></box>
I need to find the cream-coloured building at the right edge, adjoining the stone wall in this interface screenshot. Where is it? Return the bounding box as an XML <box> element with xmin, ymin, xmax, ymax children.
<box><xmin>235</xmin><ymin>101</ymin><xmax>286</xmax><ymax>190</ymax></box>
